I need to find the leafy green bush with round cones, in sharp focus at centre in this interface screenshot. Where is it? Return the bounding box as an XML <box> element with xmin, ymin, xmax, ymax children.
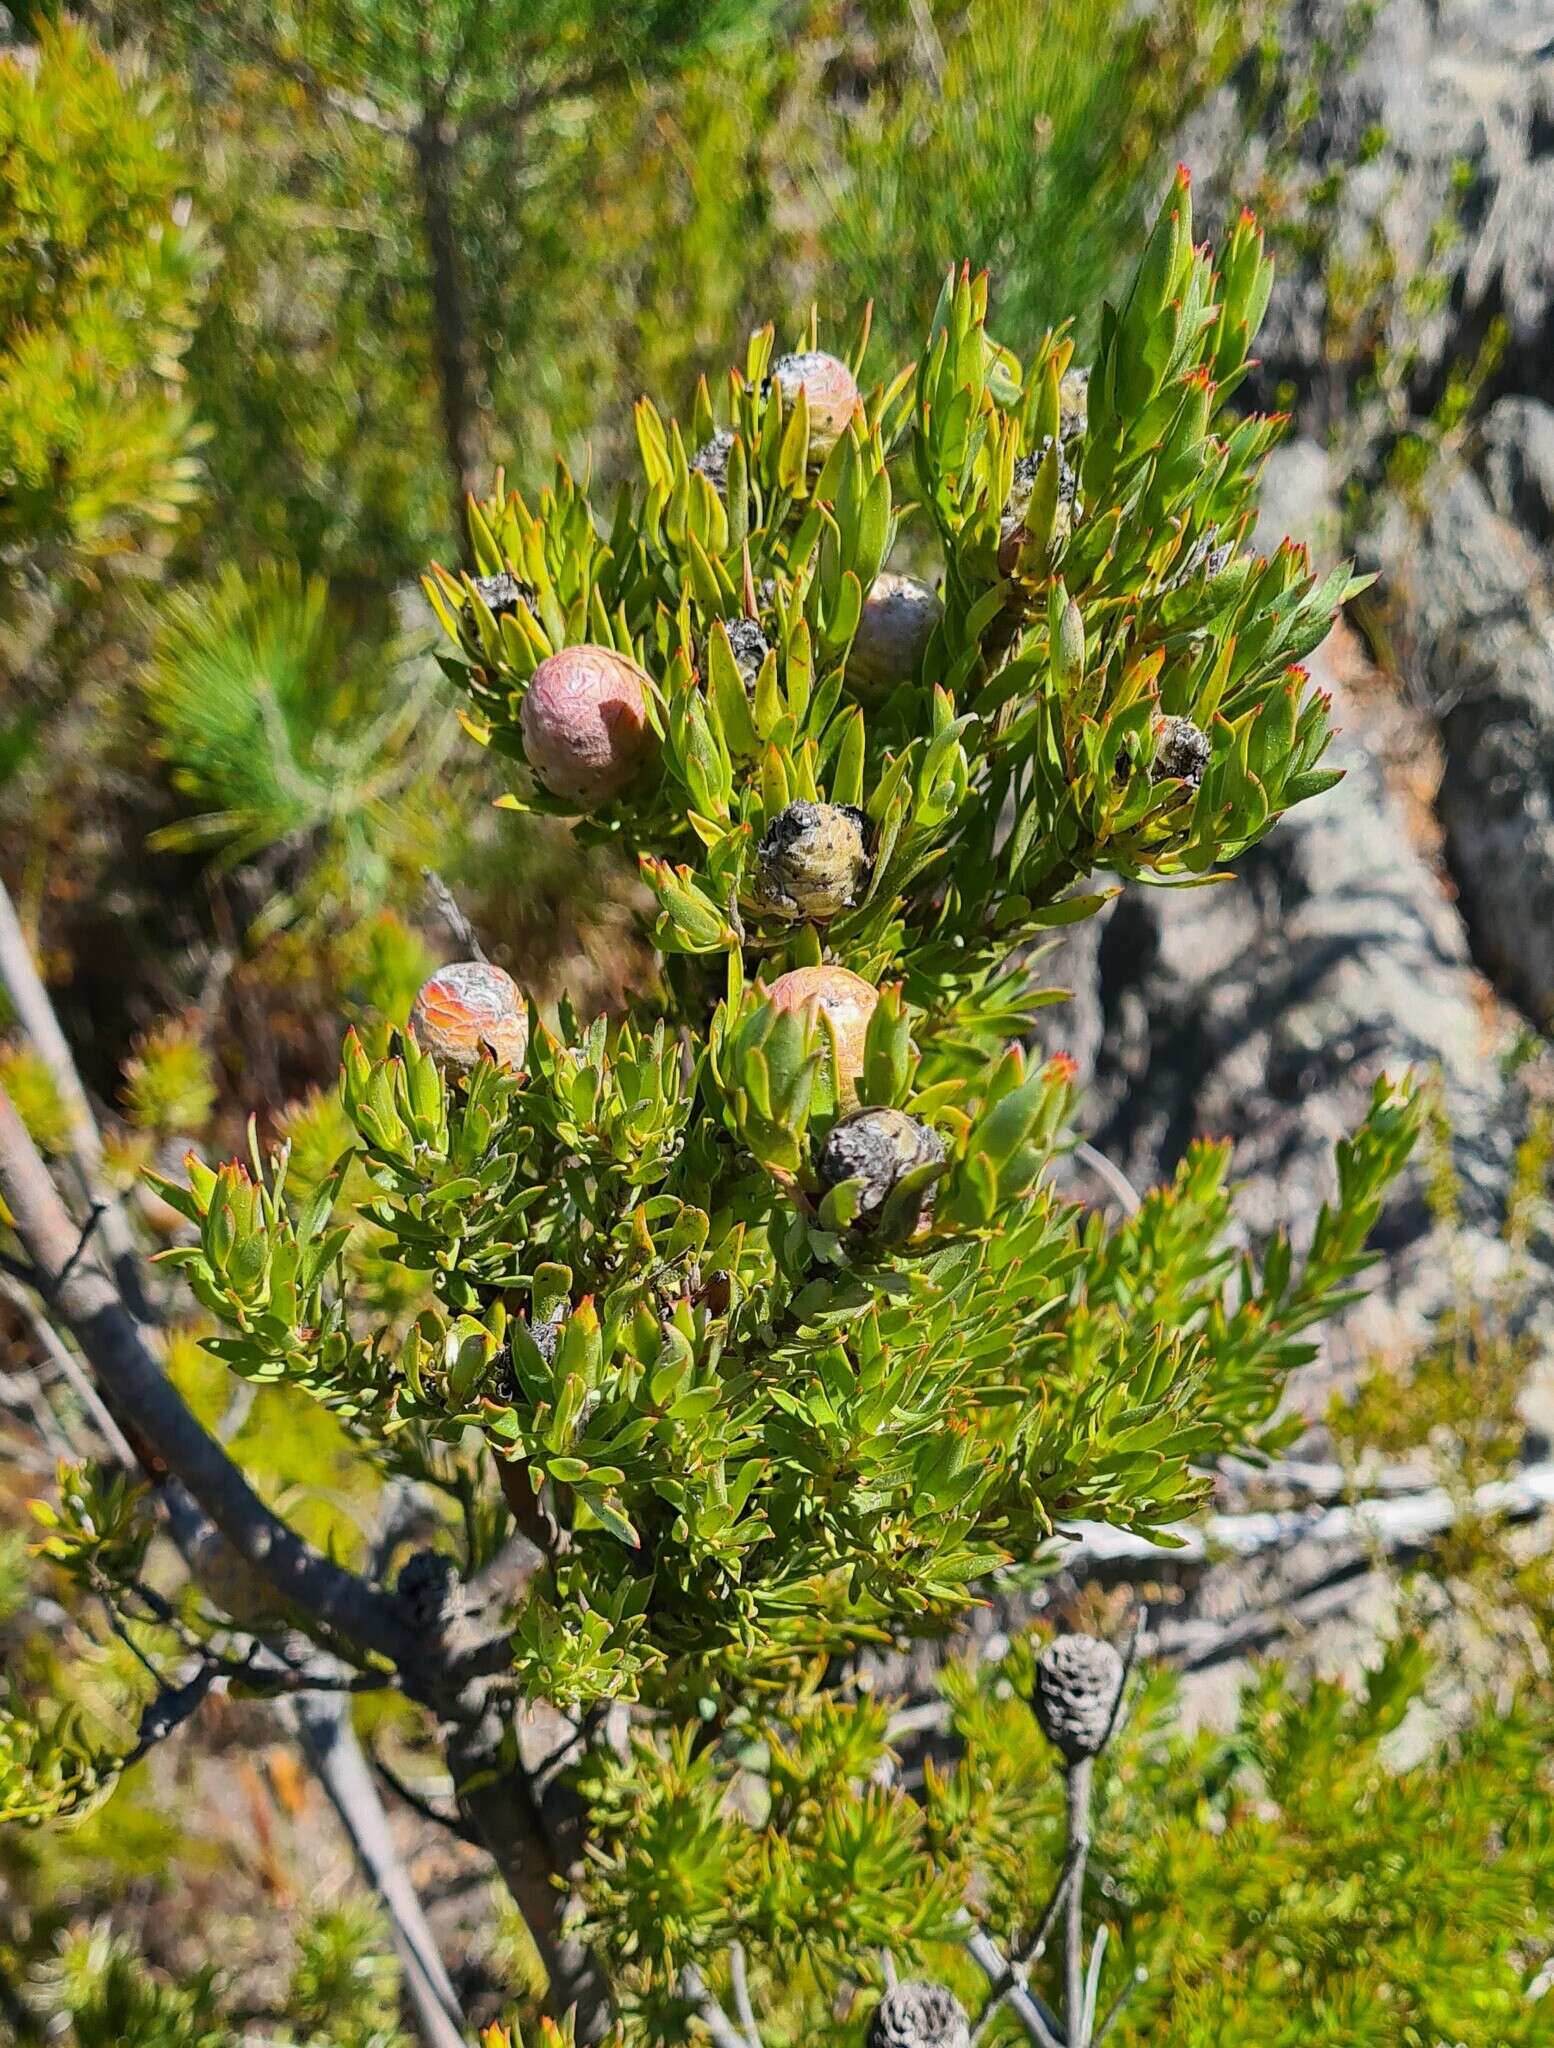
<box><xmin>0</xmin><ymin>178</ymin><xmax>1417</xmax><ymax>2048</ymax></box>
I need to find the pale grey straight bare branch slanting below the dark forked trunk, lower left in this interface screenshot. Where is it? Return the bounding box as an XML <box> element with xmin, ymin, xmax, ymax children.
<box><xmin>280</xmin><ymin>1694</ymin><xmax>465</xmax><ymax>2048</ymax></box>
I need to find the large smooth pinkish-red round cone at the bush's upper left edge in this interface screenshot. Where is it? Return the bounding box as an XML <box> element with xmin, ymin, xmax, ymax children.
<box><xmin>518</xmin><ymin>645</ymin><xmax>653</xmax><ymax>811</ymax></box>
